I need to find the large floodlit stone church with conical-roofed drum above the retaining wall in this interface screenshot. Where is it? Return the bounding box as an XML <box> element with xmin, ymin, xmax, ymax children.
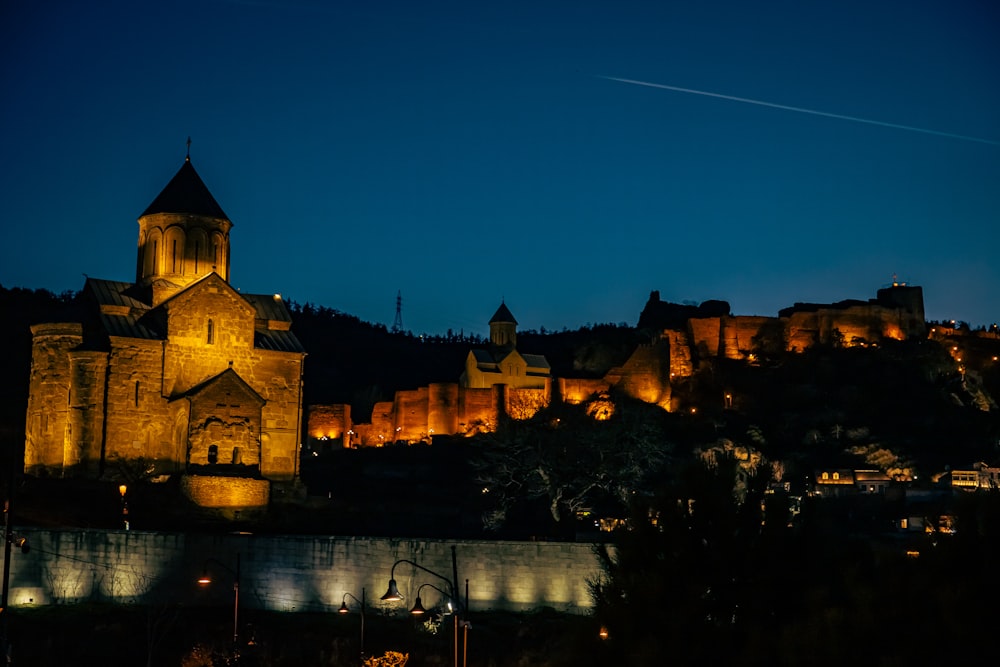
<box><xmin>24</xmin><ymin>157</ymin><xmax>305</xmax><ymax>508</ymax></box>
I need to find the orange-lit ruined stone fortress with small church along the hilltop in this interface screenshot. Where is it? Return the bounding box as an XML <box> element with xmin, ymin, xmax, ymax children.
<box><xmin>308</xmin><ymin>284</ymin><xmax>927</xmax><ymax>447</ymax></box>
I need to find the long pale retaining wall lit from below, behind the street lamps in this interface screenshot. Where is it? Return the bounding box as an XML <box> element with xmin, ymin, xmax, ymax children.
<box><xmin>9</xmin><ymin>530</ymin><xmax>600</xmax><ymax>615</ymax></box>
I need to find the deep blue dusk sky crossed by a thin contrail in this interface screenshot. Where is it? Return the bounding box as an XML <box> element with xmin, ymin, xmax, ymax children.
<box><xmin>0</xmin><ymin>0</ymin><xmax>1000</xmax><ymax>333</ymax></box>
